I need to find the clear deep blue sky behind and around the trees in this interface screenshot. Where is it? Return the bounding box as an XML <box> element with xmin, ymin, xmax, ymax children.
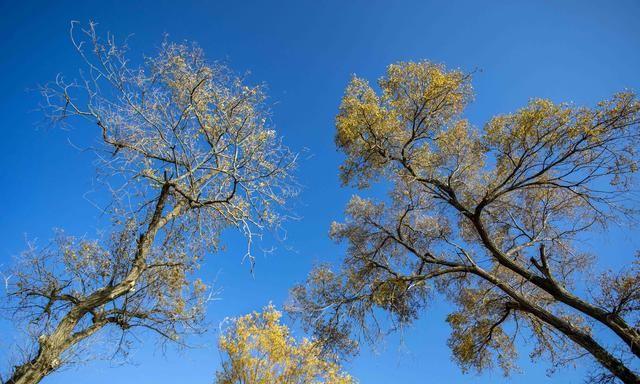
<box><xmin>0</xmin><ymin>0</ymin><xmax>640</xmax><ymax>384</ymax></box>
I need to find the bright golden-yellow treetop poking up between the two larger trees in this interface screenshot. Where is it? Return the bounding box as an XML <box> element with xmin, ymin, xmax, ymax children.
<box><xmin>216</xmin><ymin>305</ymin><xmax>355</xmax><ymax>384</ymax></box>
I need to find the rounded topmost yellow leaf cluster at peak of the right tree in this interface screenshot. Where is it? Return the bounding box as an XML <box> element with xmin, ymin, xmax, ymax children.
<box><xmin>336</xmin><ymin>61</ymin><xmax>471</xmax><ymax>187</ymax></box>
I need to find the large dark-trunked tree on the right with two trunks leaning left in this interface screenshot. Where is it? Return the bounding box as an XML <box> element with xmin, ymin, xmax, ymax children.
<box><xmin>290</xmin><ymin>61</ymin><xmax>640</xmax><ymax>383</ymax></box>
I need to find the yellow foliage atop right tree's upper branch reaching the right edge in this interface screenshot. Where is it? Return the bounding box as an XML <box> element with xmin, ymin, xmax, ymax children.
<box><xmin>483</xmin><ymin>92</ymin><xmax>640</xmax><ymax>194</ymax></box>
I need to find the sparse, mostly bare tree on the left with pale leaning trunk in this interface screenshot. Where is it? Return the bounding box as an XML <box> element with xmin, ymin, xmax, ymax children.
<box><xmin>5</xmin><ymin>24</ymin><xmax>296</xmax><ymax>384</ymax></box>
